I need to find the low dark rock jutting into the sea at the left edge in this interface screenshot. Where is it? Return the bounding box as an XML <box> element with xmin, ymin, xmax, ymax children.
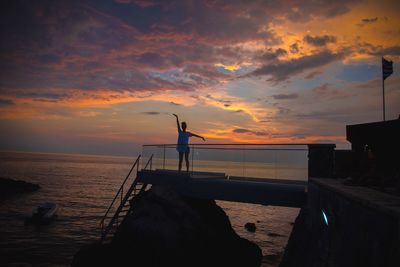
<box><xmin>0</xmin><ymin>178</ymin><xmax>40</xmax><ymax>200</ymax></box>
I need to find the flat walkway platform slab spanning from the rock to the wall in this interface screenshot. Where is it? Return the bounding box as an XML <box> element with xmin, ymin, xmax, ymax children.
<box><xmin>137</xmin><ymin>170</ymin><xmax>307</xmax><ymax>207</ymax></box>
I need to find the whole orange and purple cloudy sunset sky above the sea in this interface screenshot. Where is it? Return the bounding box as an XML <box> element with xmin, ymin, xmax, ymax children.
<box><xmin>0</xmin><ymin>0</ymin><xmax>400</xmax><ymax>155</ymax></box>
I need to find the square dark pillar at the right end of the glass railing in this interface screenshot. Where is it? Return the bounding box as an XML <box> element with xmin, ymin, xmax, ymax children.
<box><xmin>308</xmin><ymin>144</ymin><xmax>336</xmax><ymax>178</ymax></box>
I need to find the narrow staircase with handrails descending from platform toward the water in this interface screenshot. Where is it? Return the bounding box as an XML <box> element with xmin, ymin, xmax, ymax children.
<box><xmin>100</xmin><ymin>155</ymin><xmax>153</xmax><ymax>242</ymax></box>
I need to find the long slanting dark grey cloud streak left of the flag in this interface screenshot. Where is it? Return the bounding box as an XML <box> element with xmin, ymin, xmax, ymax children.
<box><xmin>247</xmin><ymin>50</ymin><xmax>344</xmax><ymax>81</ymax></box>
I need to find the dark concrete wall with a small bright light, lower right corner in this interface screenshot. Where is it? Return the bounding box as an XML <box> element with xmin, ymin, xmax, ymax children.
<box><xmin>281</xmin><ymin>178</ymin><xmax>400</xmax><ymax>267</ymax></box>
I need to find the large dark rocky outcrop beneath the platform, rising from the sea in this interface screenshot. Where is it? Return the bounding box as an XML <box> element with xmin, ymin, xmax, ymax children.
<box><xmin>72</xmin><ymin>187</ymin><xmax>262</xmax><ymax>266</ymax></box>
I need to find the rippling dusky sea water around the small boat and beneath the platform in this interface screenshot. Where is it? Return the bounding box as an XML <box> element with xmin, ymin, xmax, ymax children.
<box><xmin>0</xmin><ymin>152</ymin><xmax>298</xmax><ymax>266</ymax></box>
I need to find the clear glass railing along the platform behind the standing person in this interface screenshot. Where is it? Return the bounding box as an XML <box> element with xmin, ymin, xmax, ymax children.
<box><xmin>142</xmin><ymin>143</ymin><xmax>308</xmax><ymax>180</ymax></box>
